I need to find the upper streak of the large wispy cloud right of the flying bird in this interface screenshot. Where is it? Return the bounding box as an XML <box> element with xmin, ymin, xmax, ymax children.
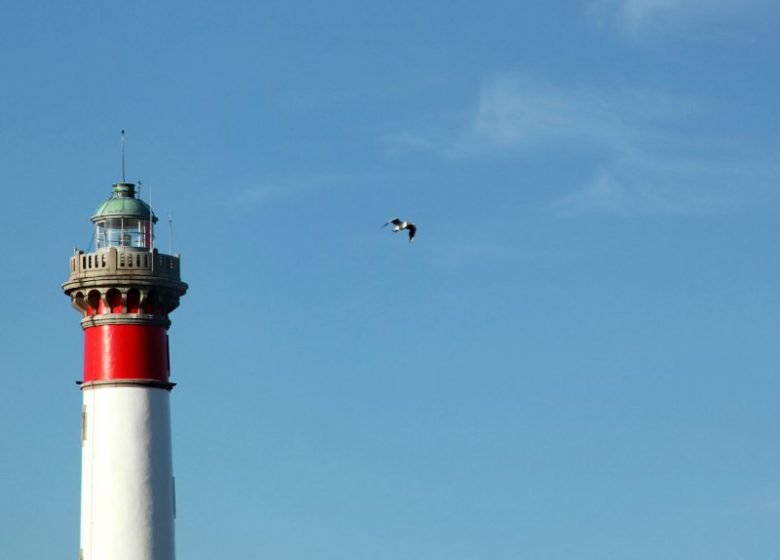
<box><xmin>389</xmin><ymin>76</ymin><xmax>696</xmax><ymax>158</ymax></box>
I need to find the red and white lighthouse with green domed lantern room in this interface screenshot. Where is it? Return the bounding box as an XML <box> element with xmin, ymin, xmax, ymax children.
<box><xmin>62</xmin><ymin>181</ymin><xmax>187</xmax><ymax>560</ymax></box>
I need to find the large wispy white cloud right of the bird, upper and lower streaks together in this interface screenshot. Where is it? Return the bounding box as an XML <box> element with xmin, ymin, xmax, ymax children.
<box><xmin>392</xmin><ymin>76</ymin><xmax>780</xmax><ymax>216</ymax></box>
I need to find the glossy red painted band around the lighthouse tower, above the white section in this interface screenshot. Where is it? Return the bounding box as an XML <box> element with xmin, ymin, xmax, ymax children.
<box><xmin>84</xmin><ymin>324</ymin><xmax>170</xmax><ymax>382</ymax></box>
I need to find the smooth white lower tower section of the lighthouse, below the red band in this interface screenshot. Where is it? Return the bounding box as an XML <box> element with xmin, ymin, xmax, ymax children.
<box><xmin>81</xmin><ymin>380</ymin><xmax>176</xmax><ymax>560</ymax></box>
